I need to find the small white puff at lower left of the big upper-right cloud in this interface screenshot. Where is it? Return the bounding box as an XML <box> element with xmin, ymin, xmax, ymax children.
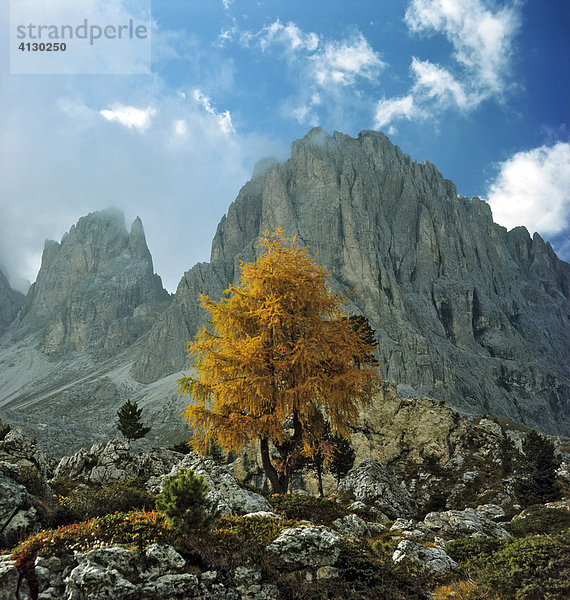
<box><xmin>411</xmin><ymin>57</ymin><xmax>470</xmax><ymax>108</ymax></box>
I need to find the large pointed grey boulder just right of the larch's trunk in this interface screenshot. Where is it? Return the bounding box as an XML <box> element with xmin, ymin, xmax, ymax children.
<box><xmin>338</xmin><ymin>459</ymin><xmax>415</xmax><ymax>518</ymax></box>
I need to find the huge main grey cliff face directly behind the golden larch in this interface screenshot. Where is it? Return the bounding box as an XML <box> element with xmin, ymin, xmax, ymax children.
<box><xmin>146</xmin><ymin>129</ymin><xmax>570</xmax><ymax>433</ymax></box>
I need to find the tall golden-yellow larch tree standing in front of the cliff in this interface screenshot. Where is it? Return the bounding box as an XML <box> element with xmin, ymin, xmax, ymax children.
<box><xmin>178</xmin><ymin>228</ymin><xmax>379</xmax><ymax>493</ymax></box>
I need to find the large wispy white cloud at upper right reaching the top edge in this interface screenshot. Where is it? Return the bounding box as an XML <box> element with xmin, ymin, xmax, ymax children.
<box><xmin>374</xmin><ymin>0</ymin><xmax>521</xmax><ymax>126</ymax></box>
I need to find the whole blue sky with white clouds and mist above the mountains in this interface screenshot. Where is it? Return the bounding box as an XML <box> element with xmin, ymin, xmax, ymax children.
<box><xmin>0</xmin><ymin>0</ymin><xmax>570</xmax><ymax>291</ymax></box>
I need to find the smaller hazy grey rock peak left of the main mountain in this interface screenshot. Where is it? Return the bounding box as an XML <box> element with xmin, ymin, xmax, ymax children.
<box><xmin>21</xmin><ymin>210</ymin><xmax>169</xmax><ymax>356</ymax></box>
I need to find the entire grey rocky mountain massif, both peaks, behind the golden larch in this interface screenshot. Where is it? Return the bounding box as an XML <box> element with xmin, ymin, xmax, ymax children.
<box><xmin>0</xmin><ymin>129</ymin><xmax>570</xmax><ymax>455</ymax></box>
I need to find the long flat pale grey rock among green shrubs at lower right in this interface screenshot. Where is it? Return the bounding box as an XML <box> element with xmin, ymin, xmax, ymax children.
<box><xmin>424</xmin><ymin>508</ymin><xmax>511</xmax><ymax>540</ymax></box>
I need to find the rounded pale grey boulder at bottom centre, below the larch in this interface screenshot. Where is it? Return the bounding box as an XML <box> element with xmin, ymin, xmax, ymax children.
<box><xmin>265</xmin><ymin>526</ymin><xmax>343</xmax><ymax>569</ymax></box>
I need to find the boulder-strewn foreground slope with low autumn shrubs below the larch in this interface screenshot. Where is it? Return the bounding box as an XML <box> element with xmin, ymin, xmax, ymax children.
<box><xmin>0</xmin><ymin>422</ymin><xmax>569</xmax><ymax>600</ymax></box>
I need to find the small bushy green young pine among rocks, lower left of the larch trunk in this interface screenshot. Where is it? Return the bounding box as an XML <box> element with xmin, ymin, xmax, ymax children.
<box><xmin>156</xmin><ymin>470</ymin><xmax>218</xmax><ymax>535</ymax></box>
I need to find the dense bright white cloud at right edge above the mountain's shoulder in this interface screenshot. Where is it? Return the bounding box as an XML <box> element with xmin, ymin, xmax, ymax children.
<box><xmin>487</xmin><ymin>142</ymin><xmax>570</xmax><ymax>236</ymax></box>
